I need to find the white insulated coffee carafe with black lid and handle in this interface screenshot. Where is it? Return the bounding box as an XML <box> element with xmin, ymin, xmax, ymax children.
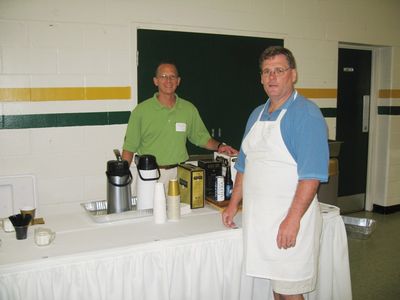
<box><xmin>135</xmin><ymin>154</ymin><xmax>160</xmax><ymax>209</ymax></box>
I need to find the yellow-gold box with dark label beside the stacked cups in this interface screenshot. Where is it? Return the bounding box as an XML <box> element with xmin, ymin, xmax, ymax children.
<box><xmin>178</xmin><ymin>164</ymin><xmax>205</xmax><ymax>209</ymax></box>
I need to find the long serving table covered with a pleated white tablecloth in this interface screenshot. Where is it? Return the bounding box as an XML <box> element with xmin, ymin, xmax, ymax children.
<box><xmin>0</xmin><ymin>205</ymin><xmax>351</xmax><ymax>300</ymax></box>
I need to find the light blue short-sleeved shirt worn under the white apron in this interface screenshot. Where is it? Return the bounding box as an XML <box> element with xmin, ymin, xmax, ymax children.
<box><xmin>235</xmin><ymin>93</ymin><xmax>329</xmax><ymax>182</ymax></box>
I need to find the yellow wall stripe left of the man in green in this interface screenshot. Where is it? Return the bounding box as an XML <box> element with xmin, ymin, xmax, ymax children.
<box><xmin>0</xmin><ymin>86</ymin><xmax>131</xmax><ymax>101</ymax></box>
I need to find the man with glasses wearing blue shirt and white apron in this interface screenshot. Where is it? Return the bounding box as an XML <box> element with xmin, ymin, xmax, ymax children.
<box><xmin>222</xmin><ymin>46</ymin><xmax>329</xmax><ymax>299</ymax></box>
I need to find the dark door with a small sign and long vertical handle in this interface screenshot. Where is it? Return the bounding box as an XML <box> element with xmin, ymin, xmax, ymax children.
<box><xmin>336</xmin><ymin>48</ymin><xmax>372</xmax><ymax>211</ymax></box>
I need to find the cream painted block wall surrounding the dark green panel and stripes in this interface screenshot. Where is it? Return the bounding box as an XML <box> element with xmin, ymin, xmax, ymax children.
<box><xmin>0</xmin><ymin>0</ymin><xmax>400</xmax><ymax>214</ymax></box>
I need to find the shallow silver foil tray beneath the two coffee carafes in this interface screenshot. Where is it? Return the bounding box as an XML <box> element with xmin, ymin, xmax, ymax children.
<box><xmin>81</xmin><ymin>197</ymin><xmax>153</xmax><ymax>223</ymax></box>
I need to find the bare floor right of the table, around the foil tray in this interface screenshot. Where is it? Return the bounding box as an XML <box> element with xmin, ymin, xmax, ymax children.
<box><xmin>345</xmin><ymin>211</ymin><xmax>400</xmax><ymax>300</ymax></box>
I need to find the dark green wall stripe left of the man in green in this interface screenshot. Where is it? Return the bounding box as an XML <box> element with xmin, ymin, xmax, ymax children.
<box><xmin>0</xmin><ymin>111</ymin><xmax>131</xmax><ymax>129</ymax></box>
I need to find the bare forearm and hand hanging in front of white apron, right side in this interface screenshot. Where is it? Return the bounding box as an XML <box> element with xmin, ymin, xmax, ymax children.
<box><xmin>276</xmin><ymin>179</ymin><xmax>319</xmax><ymax>249</ymax></box>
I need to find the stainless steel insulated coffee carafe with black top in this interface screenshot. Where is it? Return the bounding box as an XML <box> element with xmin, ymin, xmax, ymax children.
<box><xmin>106</xmin><ymin>150</ymin><xmax>132</xmax><ymax>214</ymax></box>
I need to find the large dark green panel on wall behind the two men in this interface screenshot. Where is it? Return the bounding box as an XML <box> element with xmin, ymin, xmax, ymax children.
<box><xmin>137</xmin><ymin>29</ymin><xmax>283</xmax><ymax>154</ymax></box>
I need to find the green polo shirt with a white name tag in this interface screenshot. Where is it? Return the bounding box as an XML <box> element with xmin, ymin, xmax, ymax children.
<box><xmin>123</xmin><ymin>93</ymin><xmax>211</xmax><ymax>165</ymax></box>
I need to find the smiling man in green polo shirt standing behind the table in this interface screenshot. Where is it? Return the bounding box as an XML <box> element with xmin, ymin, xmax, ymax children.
<box><xmin>122</xmin><ymin>62</ymin><xmax>237</xmax><ymax>191</ymax></box>
